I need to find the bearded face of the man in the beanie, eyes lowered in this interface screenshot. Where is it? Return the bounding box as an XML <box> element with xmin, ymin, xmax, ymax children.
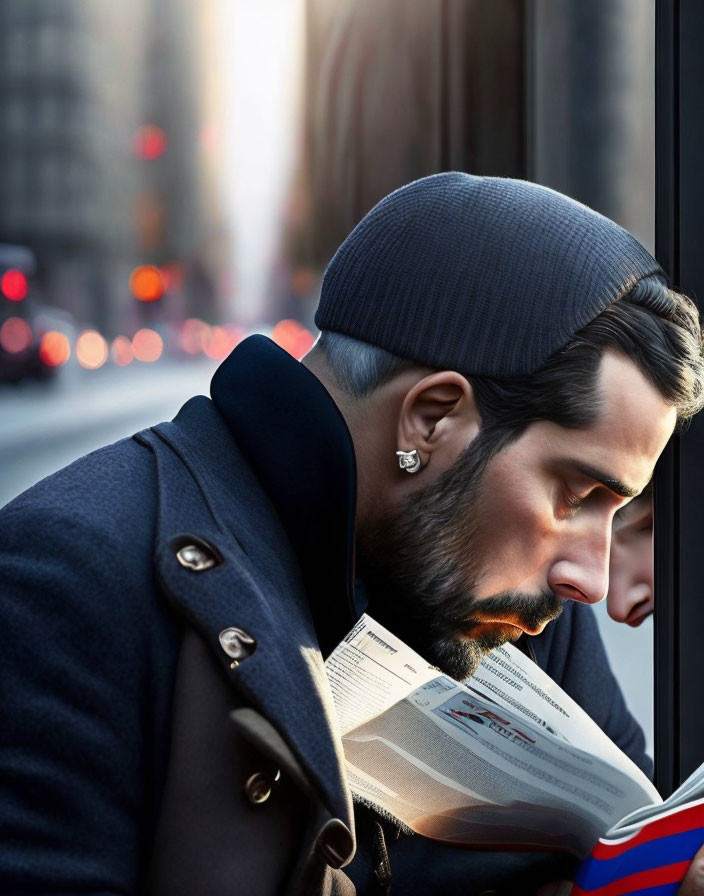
<box><xmin>359</xmin><ymin>353</ymin><xmax>676</xmax><ymax>678</ymax></box>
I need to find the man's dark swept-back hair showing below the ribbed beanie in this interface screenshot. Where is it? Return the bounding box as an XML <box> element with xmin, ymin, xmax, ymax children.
<box><xmin>318</xmin><ymin>276</ymin><xmax>704</xmax><ymax>449</ymax></box>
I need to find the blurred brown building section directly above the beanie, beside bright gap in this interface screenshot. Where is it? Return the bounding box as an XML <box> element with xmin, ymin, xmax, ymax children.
<box><xmin>280</xmin><ymin>0</ymin><xmax>526</xmax><ymax>318</ymax></box>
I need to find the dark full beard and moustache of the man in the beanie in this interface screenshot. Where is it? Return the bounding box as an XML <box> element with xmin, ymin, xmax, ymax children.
<box><xmin>358</xmin><ymin>433</ymin><xmax>562</xmax><ymax>681</ymax></box>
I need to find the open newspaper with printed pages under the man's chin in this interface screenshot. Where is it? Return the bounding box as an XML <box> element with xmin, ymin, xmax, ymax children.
<box><xmin>326</xmin><ymin>615</ymin><xmax>704</xmax><ymax>858</ymax></box>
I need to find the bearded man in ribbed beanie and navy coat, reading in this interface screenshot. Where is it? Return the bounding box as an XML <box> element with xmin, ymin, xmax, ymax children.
<box><xmin>0</xmin><ymin>173</ymin><xmax>704</xmax><ymax>896</ymax></box>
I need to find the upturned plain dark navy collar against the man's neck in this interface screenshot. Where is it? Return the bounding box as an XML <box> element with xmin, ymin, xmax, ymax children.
<box><xmin>211</xmin><ymin>336</ymin><xmax>359</xmax><ymax>656</ymax></box>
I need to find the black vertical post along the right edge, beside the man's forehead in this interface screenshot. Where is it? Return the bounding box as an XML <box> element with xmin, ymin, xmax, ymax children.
<box><xmin>655</xmin><ymin>0</ymin><xmax>704</xmax><ymax>793</ymax></box>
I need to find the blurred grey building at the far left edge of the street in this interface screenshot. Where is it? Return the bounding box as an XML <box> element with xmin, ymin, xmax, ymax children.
<box><xmin>0</xmin><ymin>0</ymin><xmax>144</xmax><ymax>331</ymax></box>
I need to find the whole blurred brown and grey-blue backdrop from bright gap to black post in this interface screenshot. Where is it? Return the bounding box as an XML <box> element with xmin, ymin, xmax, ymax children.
<box><xmin>288</xmin><ymin>0</ymin><xmax>655</xmax><ymax>324</ymax></box>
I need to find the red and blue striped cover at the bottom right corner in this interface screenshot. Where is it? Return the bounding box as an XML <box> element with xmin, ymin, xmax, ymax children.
<box><xmin>570</xmin><ymin>799</ymin><xmax>704</xmax><ymax>896</ymax></box>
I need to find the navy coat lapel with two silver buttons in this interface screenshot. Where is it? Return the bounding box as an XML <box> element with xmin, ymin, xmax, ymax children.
<box><xmin>136</xmin><ymin>397</ymin><xmax>353</xmax><ymax>829</ymax></box>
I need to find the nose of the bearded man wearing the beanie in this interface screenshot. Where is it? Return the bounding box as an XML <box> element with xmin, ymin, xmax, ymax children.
<box><xmin>548</xmin><ymin>521</ymin><xmax>611</xmax><ymax>604</ymax></box>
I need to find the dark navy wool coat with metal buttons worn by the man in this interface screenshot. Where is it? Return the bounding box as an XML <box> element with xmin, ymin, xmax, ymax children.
<box><xmin>0</xmin><ymin>340</ymin><xmax>647</xmax><ymax>896</ymax></box>
